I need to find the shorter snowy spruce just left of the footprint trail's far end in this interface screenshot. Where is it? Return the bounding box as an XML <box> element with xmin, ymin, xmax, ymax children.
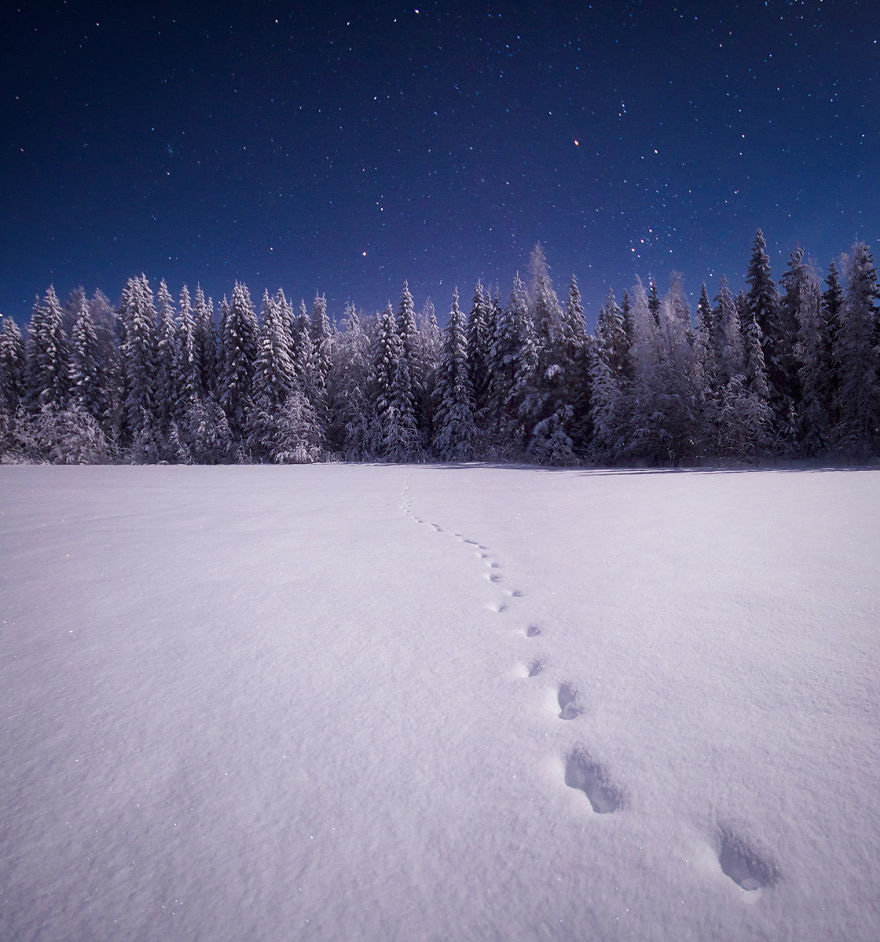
<box><xmin>371</xmin><ymin>304</ymin><xmax>420</xmax><ymax>461</ymax></box>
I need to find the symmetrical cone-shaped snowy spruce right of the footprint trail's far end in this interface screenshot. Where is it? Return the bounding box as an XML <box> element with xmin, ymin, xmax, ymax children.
<box><xmin>434</xmin><ymin>290</ymin><xmax>477</xmax><ymax>461</ymax></box>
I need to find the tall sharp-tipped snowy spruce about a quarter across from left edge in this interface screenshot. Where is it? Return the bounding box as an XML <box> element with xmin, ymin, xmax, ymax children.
<box><xmin>218</xmin><ymin>281</ymin><xmax>259</xmax><ymax>457</ymax></box>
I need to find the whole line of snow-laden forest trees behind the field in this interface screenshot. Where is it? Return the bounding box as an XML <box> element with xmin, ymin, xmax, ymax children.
<box><xmin>0</xmin><ymin>231</ymin><xmax>880</xmax><ymax>465</ymax></box>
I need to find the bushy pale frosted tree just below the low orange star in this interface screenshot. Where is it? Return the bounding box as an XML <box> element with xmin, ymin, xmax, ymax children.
<box><xmin>328</xmin><ymin>302</ymin><xmax>370</xmax><ymax>461</ymax></box>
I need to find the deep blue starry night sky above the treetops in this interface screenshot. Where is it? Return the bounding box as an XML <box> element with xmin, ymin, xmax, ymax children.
<box><xmin>0</xmin><ymin>0</ymin><xmax>880</xmax><ymax>322</ymax></box>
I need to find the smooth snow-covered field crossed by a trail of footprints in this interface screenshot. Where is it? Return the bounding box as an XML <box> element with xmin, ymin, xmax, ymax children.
<box><xmin>0</xmin><ymin>466</ymin><xmax>880</xmax><ymax>942</ymax></box>
